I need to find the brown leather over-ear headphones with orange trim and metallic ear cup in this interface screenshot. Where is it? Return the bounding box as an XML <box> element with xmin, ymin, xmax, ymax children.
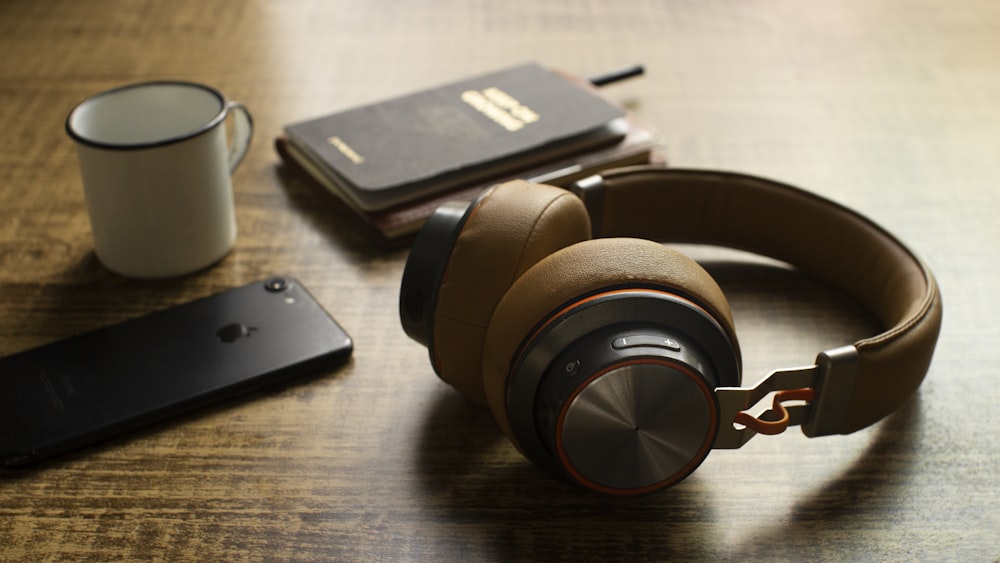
<box><xmin>400</xmin><ymin>166</ymin><xmax>942</xmax><ymax>494</ymax></box>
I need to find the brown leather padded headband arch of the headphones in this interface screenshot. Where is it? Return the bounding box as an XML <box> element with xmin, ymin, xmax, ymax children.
<box><xmin>595</xmin><ymin>167</ymin><xmax>942</xmax><ymax>433</ymax></box>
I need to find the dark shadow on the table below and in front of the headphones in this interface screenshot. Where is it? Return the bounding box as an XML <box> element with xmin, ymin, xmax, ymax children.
<box><xmin>416</xmin><ymin>378</ymin><xmax>920</xmax><ymax>560</ymax></box>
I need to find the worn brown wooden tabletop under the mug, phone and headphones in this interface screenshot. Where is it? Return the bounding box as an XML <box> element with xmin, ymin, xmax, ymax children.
<box><xmin>0</xmin><ymin>0</ymin><xmax>1000</xmax><ymax>561</ymax></box>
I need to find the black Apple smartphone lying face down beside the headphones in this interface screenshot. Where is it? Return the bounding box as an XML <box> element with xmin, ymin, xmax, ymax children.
<box><xmin>0</xmin><ymin>277</ymin><xmax>353</xmax><ymax>466</ymax></box>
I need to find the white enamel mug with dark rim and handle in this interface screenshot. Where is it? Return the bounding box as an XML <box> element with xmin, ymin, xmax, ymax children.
<box><xmin>66</xmin><ymin>81</ymin><xmax>253</xmax><ymax>278</ymax></box>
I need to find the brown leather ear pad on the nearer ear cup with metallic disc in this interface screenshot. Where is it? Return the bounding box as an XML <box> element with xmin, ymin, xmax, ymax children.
<box><xmin>482</xmin><ymin>238</ymin><xmax>738</xmax><ymax>447</ymax></box>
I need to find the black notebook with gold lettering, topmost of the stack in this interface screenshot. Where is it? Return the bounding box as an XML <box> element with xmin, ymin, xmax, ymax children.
<box><xmin>285</xmin><ymin>63</ymin><xmax>628</xmax><ymax>211</ymax></box>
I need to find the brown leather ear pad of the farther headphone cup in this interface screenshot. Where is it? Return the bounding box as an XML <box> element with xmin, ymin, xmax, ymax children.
<box><xmin>432</xmin><ymin>180</ymin><xmax>590</xmax><ymax>406</ymax></box>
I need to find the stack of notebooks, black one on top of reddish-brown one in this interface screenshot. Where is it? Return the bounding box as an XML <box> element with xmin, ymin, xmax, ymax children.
<box><xmin>275</xmin><ymin>63</ymin><xmax>661</xmax><ymax>246</ymax></box>
